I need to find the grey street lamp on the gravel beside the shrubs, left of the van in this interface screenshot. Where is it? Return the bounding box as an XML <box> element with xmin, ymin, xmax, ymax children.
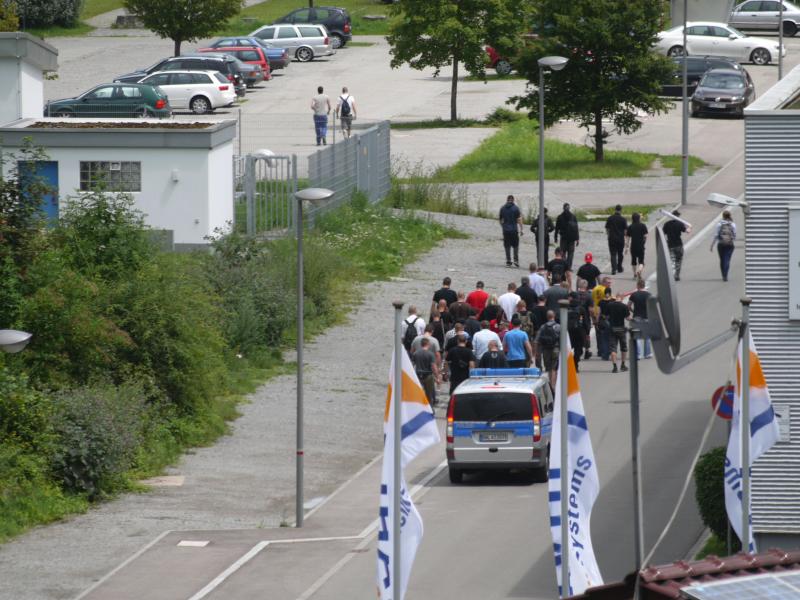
<box><xmin>294</xmin><ymin>188</ymin><xmax>335</xmax><ymax>527</ymax></box>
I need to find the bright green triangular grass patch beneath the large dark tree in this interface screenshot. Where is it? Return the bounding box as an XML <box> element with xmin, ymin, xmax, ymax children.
<box><xmin>432</xmin><ymin>120</ymin><xmax>705</xmax><ymax>183</ymax></box>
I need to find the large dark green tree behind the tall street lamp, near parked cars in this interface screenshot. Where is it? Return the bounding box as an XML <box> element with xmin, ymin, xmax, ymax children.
<box><xmin>514</xmin><ymin>0</ymin><xmax>673</xmax><ymax>161</ymax></box>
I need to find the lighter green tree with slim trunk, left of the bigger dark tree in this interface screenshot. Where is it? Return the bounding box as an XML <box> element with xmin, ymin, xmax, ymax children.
<box><xmin>387</xmin><ymin>0</ymin><xmax>528</xmax><ymax>121</ymax></box>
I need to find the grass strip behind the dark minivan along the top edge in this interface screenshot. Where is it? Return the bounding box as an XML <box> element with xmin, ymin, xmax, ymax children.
<box><xmin>219</xmin><ymin>0</ymin><xmax>389</xmax><ymax>35</ymax></box>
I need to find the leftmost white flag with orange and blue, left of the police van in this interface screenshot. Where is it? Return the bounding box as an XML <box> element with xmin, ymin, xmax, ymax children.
<box><xmin>378</xmin><ymin>352</ymin><xmax>439</xmax><ymax>600</ymax></box>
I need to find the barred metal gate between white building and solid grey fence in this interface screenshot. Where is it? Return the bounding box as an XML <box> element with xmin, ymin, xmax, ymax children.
<box><xmin>233</xmin><ymin>153</ymin><xmax>297</xmax><ymax>237</ymax></box>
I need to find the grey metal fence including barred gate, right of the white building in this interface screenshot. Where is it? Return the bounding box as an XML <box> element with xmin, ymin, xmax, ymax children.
<box><xmin>233</xmin><ymin>122</ymin><xmax>391</xmax><ymax>237</ymax></box>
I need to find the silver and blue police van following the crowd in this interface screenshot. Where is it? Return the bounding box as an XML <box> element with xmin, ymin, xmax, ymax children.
<box><xmin>447</xmin><ymin>368</ymin><xmax>553</xmax><ymax>483</ymax></box>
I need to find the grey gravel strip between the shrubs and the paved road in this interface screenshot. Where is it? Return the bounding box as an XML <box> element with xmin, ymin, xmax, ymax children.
<box><xmin>0</xmin><ymin>207</ymin><xmax>620</xmax><ymax>600</ymax></box>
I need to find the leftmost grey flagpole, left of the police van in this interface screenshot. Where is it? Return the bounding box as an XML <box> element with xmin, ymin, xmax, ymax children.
<box><xmin>391</xmin><ymin>301</ymin><xmax>406</xmax><ymax>600</ymax></box>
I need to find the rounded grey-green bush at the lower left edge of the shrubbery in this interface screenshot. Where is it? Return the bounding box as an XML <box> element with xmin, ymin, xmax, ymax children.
<box><xmin>53</xmin><ymin>384</ymin><xmax>147</xmax><ymax>498</ymax></box>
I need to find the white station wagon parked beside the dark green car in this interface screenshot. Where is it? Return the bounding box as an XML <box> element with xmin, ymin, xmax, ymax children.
<box><xmin>139</xmin><ymin>71</ymin><xmax>236</xmax><ymax>115</ymax></box>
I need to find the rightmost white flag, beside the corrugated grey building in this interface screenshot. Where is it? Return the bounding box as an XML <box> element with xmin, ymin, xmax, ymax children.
<box><xmin>725</xmin><ymin>329</ymin><xmax>780</xmax><ymax>552</ymax></box>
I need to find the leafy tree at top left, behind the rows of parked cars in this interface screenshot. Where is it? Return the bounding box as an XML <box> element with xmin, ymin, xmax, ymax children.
<box><xmin>125</xmin><ymin>0</ymin><xmax>243</xmax><ymax>56</ymax></box>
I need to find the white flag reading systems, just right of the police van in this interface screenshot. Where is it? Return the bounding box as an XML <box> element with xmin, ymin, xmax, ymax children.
<box><xmin>548</xmin><ymin>348</ymin><xmax>603</xmax><ymax>598</ymax></box>
